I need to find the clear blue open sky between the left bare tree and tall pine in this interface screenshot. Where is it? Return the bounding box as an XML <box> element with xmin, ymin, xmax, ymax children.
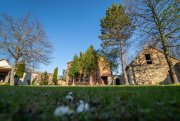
<box><xmin>0</xmin><ymin>0</ymin><xmax>121</xmax><ymax>75</ymax></box>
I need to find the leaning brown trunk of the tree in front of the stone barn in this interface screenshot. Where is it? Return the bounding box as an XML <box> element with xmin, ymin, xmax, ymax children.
<box><xmin>162</xmin><ymin>42</ymin><xmax>179</xmax><ymax>84</ymax></box>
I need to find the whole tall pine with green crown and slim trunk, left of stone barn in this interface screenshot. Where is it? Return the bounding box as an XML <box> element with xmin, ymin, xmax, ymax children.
<box><xmin>99</xmin><ymin>4</ymin><xmax>134</xmax><ymax>84</ymax></box>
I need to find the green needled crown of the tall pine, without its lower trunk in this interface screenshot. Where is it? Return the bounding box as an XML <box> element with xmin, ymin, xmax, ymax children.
<box><xmin>99</xmin><ymin>4</ymin><xmax>134</xmax><ymax>46</ymax></box>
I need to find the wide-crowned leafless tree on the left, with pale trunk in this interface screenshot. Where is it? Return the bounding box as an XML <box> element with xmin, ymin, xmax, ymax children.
<box><xmin>0</xmin><ymin>14</ymin><xmax>52</xmax><ymax>85</ymax></box>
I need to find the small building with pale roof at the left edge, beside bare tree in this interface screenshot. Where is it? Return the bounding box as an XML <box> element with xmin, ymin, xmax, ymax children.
<box><xmin>0</xmin><ymin>59</ymin><xmax>11</xmax><ymax>82</ymax></box>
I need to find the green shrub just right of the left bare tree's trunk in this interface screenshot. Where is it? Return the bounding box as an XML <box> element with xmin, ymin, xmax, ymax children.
<box><xmin>15</xmin><ymin>61</ymin><xmax>26</xmax><ymax>78</ymax></box>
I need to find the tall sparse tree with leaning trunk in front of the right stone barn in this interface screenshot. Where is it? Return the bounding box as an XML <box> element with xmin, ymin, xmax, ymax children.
<box><xmin>127</xmin><ymin>0</ymin><xmax>180</xmax><ymax>83</ymax></box>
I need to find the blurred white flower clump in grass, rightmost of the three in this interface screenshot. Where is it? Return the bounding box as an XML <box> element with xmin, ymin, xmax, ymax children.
<box><xmin>76</xmin><ymin>100</ymin><xmax>89</xmax><ymax>113</ymax></box>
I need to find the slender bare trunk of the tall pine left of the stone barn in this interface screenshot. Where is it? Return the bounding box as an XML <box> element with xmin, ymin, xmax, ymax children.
<box><xmin>120</xmin><ymin>42</ymin><xmax>129</xmax><ymax>85</ymax></box>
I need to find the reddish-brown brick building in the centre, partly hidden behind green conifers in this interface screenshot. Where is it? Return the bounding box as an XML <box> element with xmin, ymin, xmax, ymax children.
<box><xmin>66</xmin><ymin>57</ymin><xmax>111</xmax><ymax>85</ymax></box>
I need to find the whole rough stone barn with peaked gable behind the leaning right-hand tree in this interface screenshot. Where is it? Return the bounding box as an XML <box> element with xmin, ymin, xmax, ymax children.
<box><xmin>126</xmin><ymin>46</ymin><xmax>180</xmax><ymax>85</ymax></box>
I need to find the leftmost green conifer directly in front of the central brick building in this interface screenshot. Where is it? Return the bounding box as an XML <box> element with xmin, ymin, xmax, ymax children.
<box><xmin>69</xmin><ymin>55</ymin><xmax>80</xmax><ymax>77</ymax></box>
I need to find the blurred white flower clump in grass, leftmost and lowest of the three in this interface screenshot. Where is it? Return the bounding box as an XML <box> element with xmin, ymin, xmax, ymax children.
<box><xmin>54</xmin><ymin>106</ymin><xmax>74</xmax><ymax>117</ymax></box>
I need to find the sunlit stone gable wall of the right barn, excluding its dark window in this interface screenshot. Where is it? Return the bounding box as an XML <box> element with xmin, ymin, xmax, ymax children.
<box><xmin>131</xmin><ymin>47</ymin><xmax>180</xmax><ymax>85</ymax></box>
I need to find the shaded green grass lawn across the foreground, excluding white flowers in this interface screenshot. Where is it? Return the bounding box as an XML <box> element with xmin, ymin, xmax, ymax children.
<box><xmin>0</xmin><ymin>86</ymin><xmax>180</xmax><ymax>121</ymax></box>
